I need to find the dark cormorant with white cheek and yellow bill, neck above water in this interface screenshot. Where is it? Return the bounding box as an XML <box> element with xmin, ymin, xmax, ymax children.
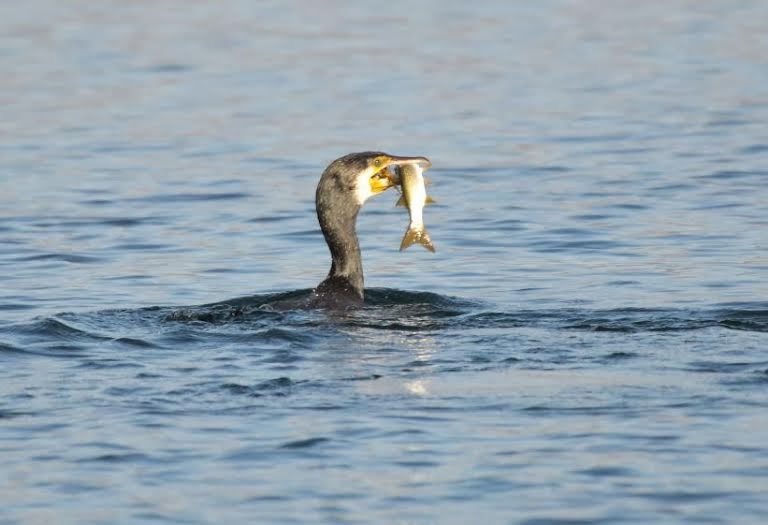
<box><xmin>311</xmin><ymin>151</ymin><xmax>431</xmax><ymax>308</ymax></box>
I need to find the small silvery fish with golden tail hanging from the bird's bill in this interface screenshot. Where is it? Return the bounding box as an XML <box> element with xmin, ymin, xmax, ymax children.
<box><xmin>395</xmin><ymin>164</ymin><xmax>435</xmax><ymax>253</ymax></box>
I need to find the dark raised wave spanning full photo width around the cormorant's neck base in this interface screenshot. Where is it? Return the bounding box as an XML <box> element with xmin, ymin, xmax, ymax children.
<box><xmin>0</xmin><ymin>288</ymin><xmax>768</xmax><ymax>357</ymax></box>
